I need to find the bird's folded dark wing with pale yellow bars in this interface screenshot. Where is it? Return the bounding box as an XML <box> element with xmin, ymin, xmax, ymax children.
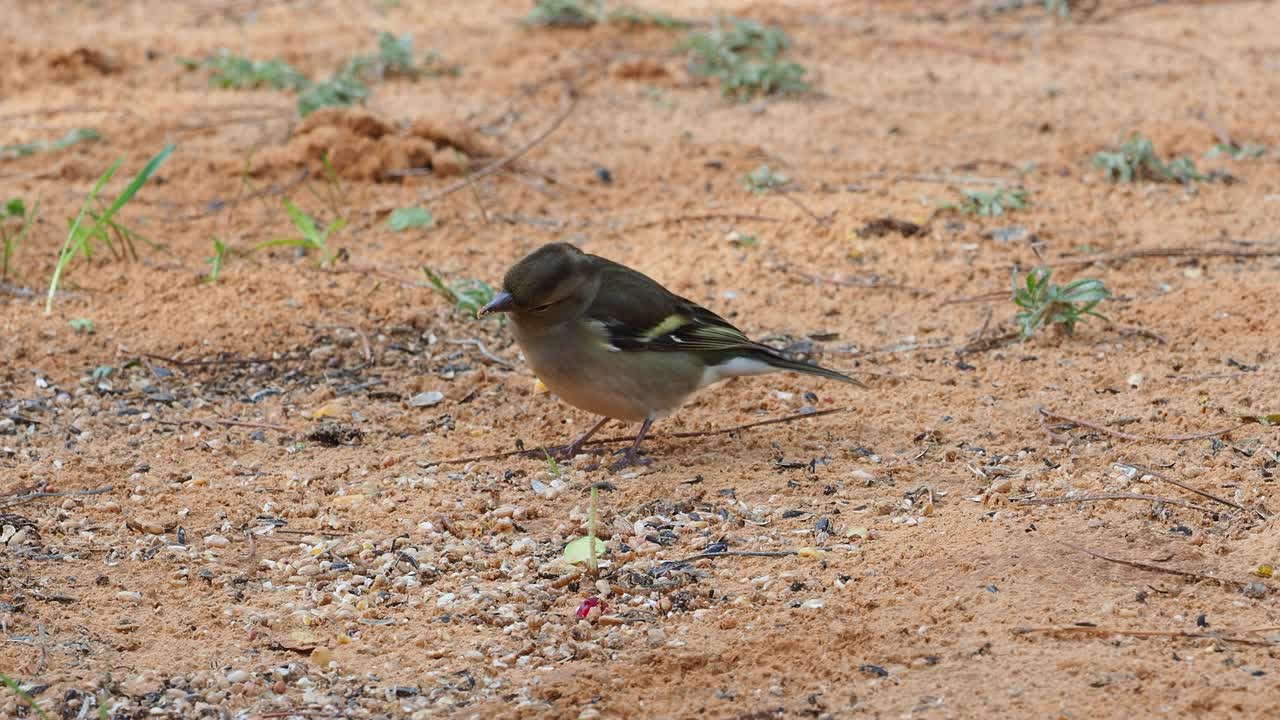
<box><xmin>586</xmin><ymin>260</ymin><xmax>769</xmax><ymax>352</ymax></box>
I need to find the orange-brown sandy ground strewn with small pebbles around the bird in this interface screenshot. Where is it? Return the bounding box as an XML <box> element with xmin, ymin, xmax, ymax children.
<box><xmin>0</xmin><ymin>0</ymin><xmax>1280</xmax><ymax>719</ymax></box>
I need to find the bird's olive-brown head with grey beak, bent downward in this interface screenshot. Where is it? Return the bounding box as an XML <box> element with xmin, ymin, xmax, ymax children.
<box><xmin>479</xmin><ymin>242</ymin><xmax>598</xmax><ymax>324</ymax></box>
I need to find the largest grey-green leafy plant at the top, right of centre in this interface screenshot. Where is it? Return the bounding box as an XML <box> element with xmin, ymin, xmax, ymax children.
<box><xmin>681</xmin><ymin>18</ymin><xmax>809</xmax><ymax>100</ymax></box>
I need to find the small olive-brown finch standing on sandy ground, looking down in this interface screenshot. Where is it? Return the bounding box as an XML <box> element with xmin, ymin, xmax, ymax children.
<box><xmin>477</xmin><ymin>242</ymin><xmax>867</xmax><ymax>471</ymax></box>
